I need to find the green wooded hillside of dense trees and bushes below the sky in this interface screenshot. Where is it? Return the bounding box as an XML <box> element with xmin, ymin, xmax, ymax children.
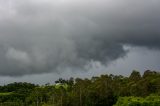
<box><xmin>0</xmin><ymin>70</ymin><xmax>160</xmax><ymax>106</ymax></box>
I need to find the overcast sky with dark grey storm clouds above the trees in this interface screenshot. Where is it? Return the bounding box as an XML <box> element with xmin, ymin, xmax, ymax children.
<box><xmin>0</xmin><ymin>0</ymin><xmax>160</xmax><ymax>84</ymax></box>
